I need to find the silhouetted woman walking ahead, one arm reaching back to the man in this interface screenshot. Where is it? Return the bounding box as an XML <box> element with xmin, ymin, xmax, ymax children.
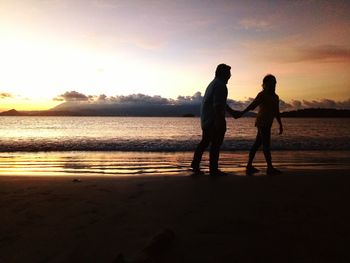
<box><xmin>241</xmin><ymin>75</ymin><xmax>283</xmax><ymax>175</ymax></box>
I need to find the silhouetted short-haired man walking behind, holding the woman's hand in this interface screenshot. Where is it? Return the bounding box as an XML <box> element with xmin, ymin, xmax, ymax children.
<box><xmin>191</xmin><ymin>64</ymin><xmax>238</xmax><ymax>176</ymax></box>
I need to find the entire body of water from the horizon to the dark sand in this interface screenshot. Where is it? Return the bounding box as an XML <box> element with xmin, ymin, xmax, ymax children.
<box><xmin>0</xmin><ymin>117</ymin><xmax>350</xmax><ymax>178</ymax></box>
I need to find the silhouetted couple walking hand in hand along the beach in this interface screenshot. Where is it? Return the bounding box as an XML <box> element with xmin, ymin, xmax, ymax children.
<box><xmin>191</xmin><ymin>64</ymin><xmax>283</xmax><ymax>176</ymax></box>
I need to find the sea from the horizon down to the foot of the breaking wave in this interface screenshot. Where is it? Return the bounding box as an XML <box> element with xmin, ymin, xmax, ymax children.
<box><xmin>0</xmin><ymin>117</ymin><xmax>350</xmax><ymax>152</ymax></box>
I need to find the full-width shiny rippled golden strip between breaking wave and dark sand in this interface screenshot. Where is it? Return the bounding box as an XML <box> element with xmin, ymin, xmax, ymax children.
<box><xmin>0</xmin><ymin>151</ymin><xmax>350</xmax><ymax>176</ymax></box>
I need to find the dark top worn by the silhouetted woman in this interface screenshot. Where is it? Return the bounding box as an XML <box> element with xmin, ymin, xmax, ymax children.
<box><xmin>254</xmin><ymin>91</ymin><xmax>279</xmax><ymax>127</ymax></box>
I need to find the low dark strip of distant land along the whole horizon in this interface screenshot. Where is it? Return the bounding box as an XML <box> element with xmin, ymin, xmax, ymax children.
<box><xmin>0</xmin><ymin>108</ymin><xmax>350</xmax><ymax>118</ymax></box>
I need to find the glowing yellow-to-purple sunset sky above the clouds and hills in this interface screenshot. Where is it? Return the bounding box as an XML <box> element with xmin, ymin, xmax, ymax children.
<box><xmin>0</xmin><ymin>0</ymin><xmax>350</xmax><ymax>110</ymax></box>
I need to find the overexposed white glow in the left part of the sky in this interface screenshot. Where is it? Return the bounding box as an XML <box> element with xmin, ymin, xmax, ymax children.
<box><xmin>0</xmin><ymin>29</ymin><xmax>206</xmax><ymax>108</ymax></box>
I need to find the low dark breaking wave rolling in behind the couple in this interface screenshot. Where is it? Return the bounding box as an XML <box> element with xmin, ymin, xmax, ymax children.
<box><xmin>0</xmin><ymin>138</ymin><xmax>350</xmax><ymax>152</ymax></box>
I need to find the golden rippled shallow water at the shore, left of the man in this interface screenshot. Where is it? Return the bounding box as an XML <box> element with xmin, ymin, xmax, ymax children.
<box><xmin>0</xmin><ymin>152</ymin><xmax>196</xmax><ymax>177</ymax></box>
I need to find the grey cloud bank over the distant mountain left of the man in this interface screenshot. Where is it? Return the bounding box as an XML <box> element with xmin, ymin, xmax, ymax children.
<box><xmin>51</xmin><ymin>91</ymin><xmax>202</xmax><ymax>116</ymax></box>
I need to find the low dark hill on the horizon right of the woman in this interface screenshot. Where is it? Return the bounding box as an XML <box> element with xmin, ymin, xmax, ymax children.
<box><xmin>281</xmin><ymin>108</ymin><xmax>350</xmax><ymax>118</ymax></box>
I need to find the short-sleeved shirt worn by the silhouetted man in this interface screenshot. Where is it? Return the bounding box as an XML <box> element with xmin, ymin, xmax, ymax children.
<box><xmin>201</xmin><ymin>78</ymin><xmax>227</xmax><ymax>129</ymax></box>
